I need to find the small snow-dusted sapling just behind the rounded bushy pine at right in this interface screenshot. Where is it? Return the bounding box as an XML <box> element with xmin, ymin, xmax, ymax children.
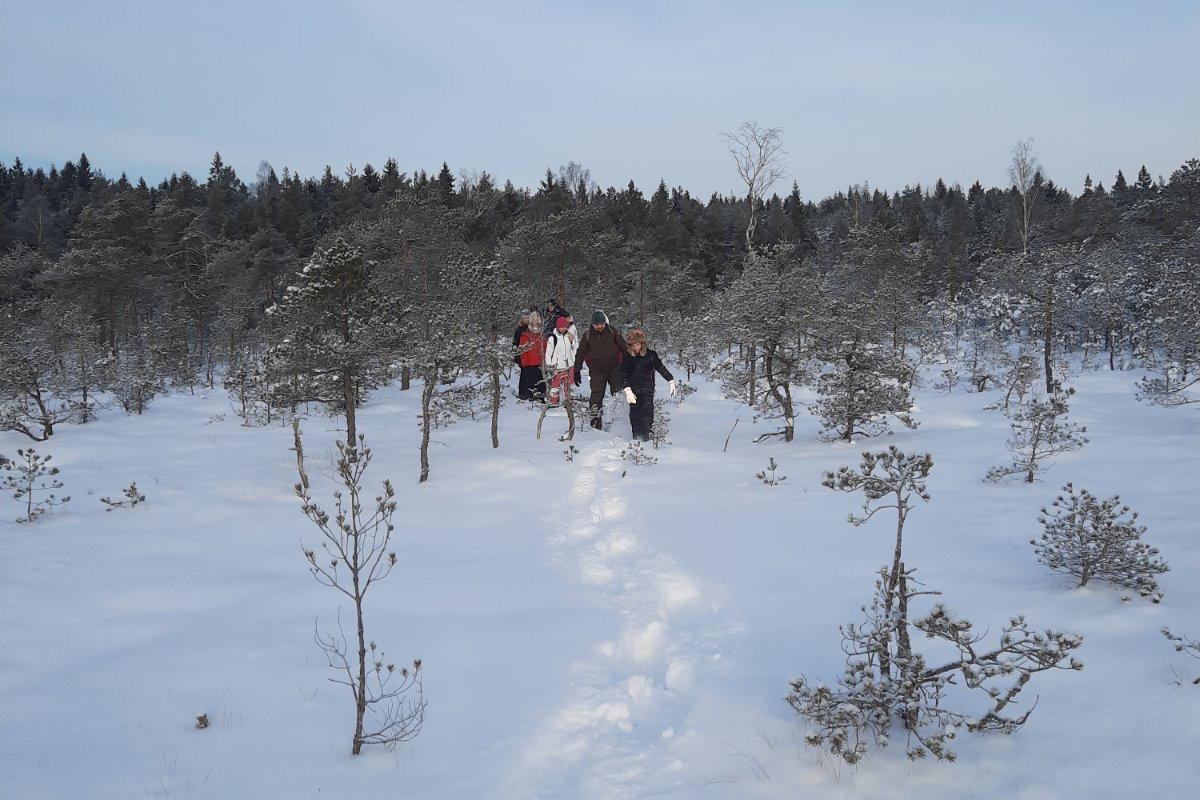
<box><xmin>984</xmin><ymin>389</ymin><xmax>1087</xmax><ymax>483</ymax></box>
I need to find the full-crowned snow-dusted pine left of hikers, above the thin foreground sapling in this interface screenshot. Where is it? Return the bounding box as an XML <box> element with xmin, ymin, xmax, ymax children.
<box><xmin>268</xmin><ymin>239</ymin><xmax>398</xmax><ymax>447</ymax></box>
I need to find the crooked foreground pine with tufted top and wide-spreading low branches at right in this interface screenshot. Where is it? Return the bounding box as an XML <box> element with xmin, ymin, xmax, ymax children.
<box><xmin>786</xmin><ymin>447</ymin><xmax>1082</xmax><ymax>764</ymax></box>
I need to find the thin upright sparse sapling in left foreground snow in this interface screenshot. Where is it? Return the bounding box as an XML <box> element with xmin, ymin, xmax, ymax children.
<box><xmin>292</xmin><ymin>420</ymin><xmax>425</xmax><ymax>756</ymax></box>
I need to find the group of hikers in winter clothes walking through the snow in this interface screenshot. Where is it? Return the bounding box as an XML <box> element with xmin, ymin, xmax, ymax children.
<box><xmin>512</xmin><ymin>297</ymin><xmax>678</xmax><ymax>441</ymax></box>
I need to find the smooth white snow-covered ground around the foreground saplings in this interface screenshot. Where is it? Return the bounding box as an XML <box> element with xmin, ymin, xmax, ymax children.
<box><xmin>0</xmin><ymin>372</ymin><xmax>1200</xmax><ymax>800</ymax></box>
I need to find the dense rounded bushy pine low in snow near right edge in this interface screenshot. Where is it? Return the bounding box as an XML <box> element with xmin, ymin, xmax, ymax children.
<box><xmin>1030</xmin><ymin>483</ymin><xmax>1168</xmax><ymax>603</ymax></box>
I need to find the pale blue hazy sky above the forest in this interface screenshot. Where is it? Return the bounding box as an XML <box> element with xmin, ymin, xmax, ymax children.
<box><xmin>0</xmin><ymin>0</ymin><xmax>1200</xmax><ymax>198</ymax></box>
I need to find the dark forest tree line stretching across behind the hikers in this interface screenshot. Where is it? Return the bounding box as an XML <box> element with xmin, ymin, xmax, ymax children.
<box><xmin>0</xmin><ymin>143</ymin><xmax>1200</xmax><ymax>474</ymax></box>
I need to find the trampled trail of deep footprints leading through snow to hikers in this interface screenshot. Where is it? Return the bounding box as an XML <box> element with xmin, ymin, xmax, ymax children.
<box><xmin>508</xmin><ymin>437</ymin><xmax>724</xmax><ymax>800</ymax></box>
